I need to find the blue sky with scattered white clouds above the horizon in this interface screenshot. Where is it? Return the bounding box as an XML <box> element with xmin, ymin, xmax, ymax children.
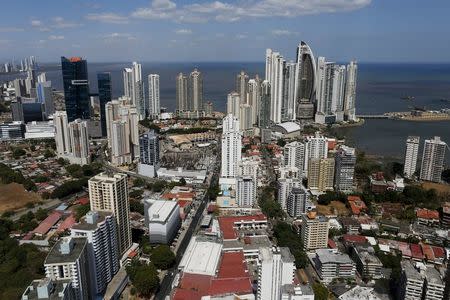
<box><xmin>0</xmin><ymin>0</ymin><xmax>450</xmax><ymax>62</ymax></box>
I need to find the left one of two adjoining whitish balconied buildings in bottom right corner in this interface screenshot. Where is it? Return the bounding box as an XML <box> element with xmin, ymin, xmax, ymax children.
<box><xmin>399</xmin><ymin>260</ymin><xmax>425</xmax><ymax>300</ymax></box>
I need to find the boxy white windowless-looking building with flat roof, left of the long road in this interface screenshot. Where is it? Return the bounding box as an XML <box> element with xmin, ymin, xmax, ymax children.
<box><xmin>144</xmin><ymin>199</ymin><xmax>181</xmax><ymax>244</ymax></box>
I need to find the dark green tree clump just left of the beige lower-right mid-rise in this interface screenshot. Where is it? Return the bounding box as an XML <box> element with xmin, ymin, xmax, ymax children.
<box><xmin>273</xmin><ymin>222</ymin><xmax>309</xmax><ymax>268</ymax></box>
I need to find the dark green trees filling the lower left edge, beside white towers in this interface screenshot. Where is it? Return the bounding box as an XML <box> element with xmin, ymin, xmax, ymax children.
<box><xmin>0</xmin><ymin>219</ymin><xmax>45</xmax><ymax>299</ymax></box>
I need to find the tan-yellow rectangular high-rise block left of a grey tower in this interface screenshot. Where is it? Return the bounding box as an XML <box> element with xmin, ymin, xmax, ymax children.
<box><xmin>308</xmin><ymin>158</ymin><xmax>334</xmax><ymax>193</ymax></box>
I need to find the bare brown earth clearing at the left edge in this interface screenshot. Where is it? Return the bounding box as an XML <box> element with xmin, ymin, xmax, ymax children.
<box><xmin>0</xmin><ymin>183</ymin><xmax>41</xmax><ymax>214</ymax></box>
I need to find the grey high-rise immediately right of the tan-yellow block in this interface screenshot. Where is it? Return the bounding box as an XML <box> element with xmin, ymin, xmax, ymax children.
<box><xmin>334</xmin><ymin>145</ymin><xmax>356</xmax><ymax>193</ymax></box>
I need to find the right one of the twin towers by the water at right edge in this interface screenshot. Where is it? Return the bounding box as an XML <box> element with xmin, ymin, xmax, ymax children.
<box><xmin>420</xmin><ymin>136</ymin><xmax>448</xmax><ymax>182</ymax></box>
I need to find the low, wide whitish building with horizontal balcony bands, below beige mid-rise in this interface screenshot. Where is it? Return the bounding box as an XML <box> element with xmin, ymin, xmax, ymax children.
<box><xmin>313</xmin><ymin>249</ymin><xmax>356</xmax><ymax>283</ymax></box>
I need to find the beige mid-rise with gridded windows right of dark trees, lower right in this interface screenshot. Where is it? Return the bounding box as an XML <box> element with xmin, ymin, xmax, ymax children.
<box><xmin>300</xmin><ymin>212</ymin><xmax>329</xmax><ymax>251</ymax></box>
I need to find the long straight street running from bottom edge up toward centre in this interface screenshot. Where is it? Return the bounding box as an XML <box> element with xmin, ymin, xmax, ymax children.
<box><xmin>155</xmin><ymin>175</ymin><xmax>218</xmax><ymax>300</ymax></box>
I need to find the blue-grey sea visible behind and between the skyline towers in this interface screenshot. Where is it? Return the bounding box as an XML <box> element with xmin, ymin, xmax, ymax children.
<box><xmin>0</xmin><ymin>62</ymin><xmax>450</xmax><ymax>161</ymax></box>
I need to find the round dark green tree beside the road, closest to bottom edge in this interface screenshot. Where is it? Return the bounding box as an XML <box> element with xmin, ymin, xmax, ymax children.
<box><xmin>127</xmin><ymin>260</ymin><xmax>159</xmax><ymax>298</ymax></box>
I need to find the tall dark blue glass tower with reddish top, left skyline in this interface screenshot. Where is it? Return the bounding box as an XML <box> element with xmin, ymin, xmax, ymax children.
<box><xmin>61</xmin><ymin>56</ymin><xmax>91</xmax><ymax>122</ymax></box>
